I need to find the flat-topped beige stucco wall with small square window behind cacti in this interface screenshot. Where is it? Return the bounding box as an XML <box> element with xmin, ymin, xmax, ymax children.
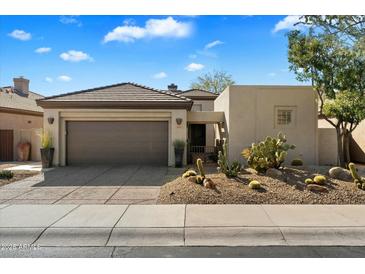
<box><xmin>214</xmin><ymin>85</ymin><xmax>318</xmax><ymax>164</ymax></box>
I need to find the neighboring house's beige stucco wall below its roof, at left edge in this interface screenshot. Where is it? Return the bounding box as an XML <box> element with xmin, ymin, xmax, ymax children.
<box><xmin>0</xmin><ymin>112</ymin><xmax>43</xmax><ymax>161</ymax></box>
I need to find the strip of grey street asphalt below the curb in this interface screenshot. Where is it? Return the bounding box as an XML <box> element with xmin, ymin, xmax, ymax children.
<box><xmin>0</xmin><ymin>246</ymin><xmax>365</xmax><ymax>258</ymax></box>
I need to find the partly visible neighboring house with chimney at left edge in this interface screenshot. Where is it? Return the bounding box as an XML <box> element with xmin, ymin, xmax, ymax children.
<box><xmin>0</xmin><ymin>77</ymin><xmax>43</xmax><ymax>161</ymax></box>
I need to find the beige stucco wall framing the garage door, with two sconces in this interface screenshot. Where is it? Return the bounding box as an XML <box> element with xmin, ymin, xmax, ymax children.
<box><xmin>44</xmin><ymin>109</ymin><xmax>187</xmax><ymax>166</ymax></box>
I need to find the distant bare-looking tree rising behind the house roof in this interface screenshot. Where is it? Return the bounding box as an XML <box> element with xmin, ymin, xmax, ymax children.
<box><xmin>190</xmin><ymin>71</ymin><xmax>235</xmax><ymax>94</ymax></box>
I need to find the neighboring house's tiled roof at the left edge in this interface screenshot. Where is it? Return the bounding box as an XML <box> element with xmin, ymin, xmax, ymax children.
<box><xmin>0</xmin><ymin>86</ymin><xmax>43</xmax><ymax>116</ymax></box>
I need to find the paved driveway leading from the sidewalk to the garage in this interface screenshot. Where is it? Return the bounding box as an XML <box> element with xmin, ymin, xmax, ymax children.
<box><xmin>0</xmin><ymin>166</ymin><xmax>183</xmax><ymax>204</ymax></box>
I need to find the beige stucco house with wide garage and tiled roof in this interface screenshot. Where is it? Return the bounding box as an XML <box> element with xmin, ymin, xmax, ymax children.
<box><xmin>37</xmin><ymin>83</ymin><xmax>362</xmax><ymax>166</ymax></box>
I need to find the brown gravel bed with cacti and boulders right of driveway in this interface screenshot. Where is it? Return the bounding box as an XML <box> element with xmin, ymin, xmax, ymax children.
<box><xmin>157</xmin><ymin>167</ymin><xmax>365</xmax><ymax>204</ymax></box>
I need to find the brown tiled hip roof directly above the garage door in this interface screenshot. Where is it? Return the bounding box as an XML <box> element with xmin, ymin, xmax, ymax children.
<box><xmin>37</xmin><ymin>82</ymin><xmax>193</xmax><ymax>109</ymax></box>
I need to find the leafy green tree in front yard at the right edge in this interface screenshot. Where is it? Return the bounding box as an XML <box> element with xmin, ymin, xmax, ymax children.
<box><xmin>288</xmin><ymin>31</ymin><xmax>365</xmax><ymax>166</ymax></box>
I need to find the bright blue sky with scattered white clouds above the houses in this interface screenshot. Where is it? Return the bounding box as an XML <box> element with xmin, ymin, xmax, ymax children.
<box><xmin>0</xmin><ymin>16</ymin><xmax>300</xmax><ymax>95</ymax></box>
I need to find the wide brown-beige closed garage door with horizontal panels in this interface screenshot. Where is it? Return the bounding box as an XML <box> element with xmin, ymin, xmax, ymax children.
<box><xmin>66</xmin><ymin>121</ymin><xmax>168</xmax><ymax>165</ymax></box>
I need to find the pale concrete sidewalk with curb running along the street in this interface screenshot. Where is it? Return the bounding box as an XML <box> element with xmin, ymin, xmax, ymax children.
<box><xmin>0</xmin><ymin>204</ymin><xmax>365</xmax><ymax>247</ymax></box>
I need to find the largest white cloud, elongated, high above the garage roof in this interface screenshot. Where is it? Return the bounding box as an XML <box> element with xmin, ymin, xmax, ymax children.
<box><xmin>103</xmin><ymin>16</ymin><xmax>192</xmax><ymax>43</ymax></box>
